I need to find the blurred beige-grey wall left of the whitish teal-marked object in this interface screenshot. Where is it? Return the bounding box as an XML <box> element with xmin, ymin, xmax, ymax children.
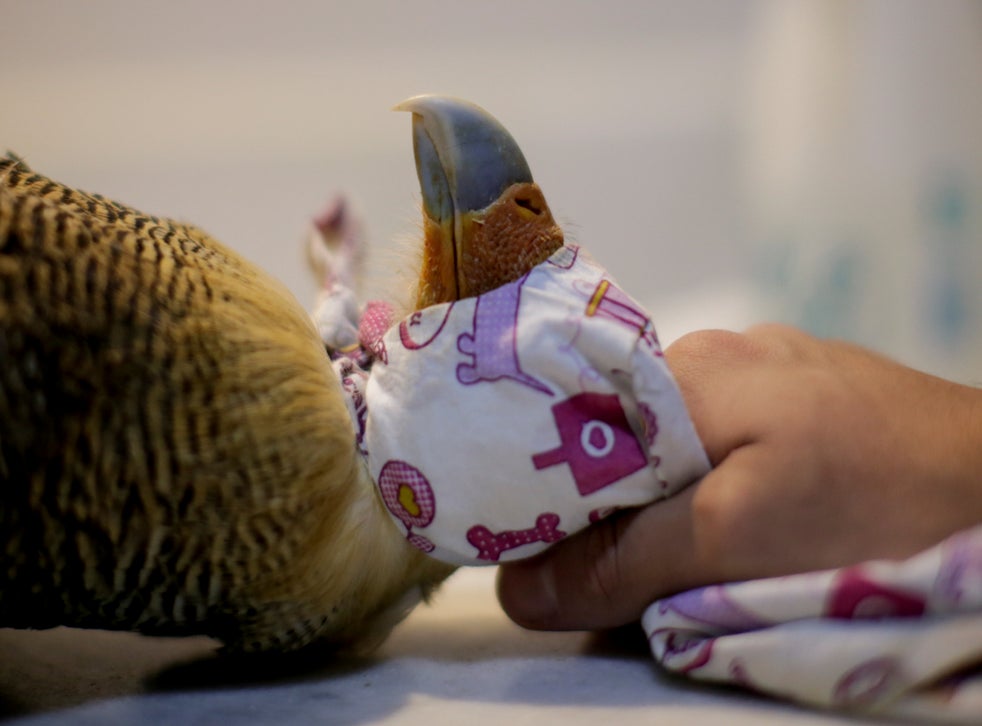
<box><xmin>0</xmin><ymin>0</ymin><xmax>753</xmax><ymax>306</ymax></box>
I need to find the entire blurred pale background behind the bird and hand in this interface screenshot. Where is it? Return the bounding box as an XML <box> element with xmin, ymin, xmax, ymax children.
<box><xmin>0</xmin><ymin>0</ymin><xmax>982</xmax><ymax>382</ymax></box>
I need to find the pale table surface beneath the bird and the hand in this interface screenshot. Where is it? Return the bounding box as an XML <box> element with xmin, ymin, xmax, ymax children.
<box><xmin>0</xmin><ymin>568</ymin><xmax>884</xmax><ymax>726</ymax></box>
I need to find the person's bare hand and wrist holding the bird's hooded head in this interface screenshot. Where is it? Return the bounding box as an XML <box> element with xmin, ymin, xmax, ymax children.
<box><xmin>498</xmin><ymin>325</ymin><xmax>982</xmax><ymax>630</ymax></box>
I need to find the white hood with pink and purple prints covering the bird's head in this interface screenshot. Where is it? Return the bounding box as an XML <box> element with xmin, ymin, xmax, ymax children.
<box><xmin>363</xmin><ymin>246</ymin><xmax>709</xmax><ymax>565</ymax></box>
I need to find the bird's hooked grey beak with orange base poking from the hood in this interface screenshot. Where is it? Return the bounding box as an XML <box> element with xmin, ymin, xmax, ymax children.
<box><xmin>395</xmin><ymin>96</ymin><xmax>563</xmax><ymax>308</ymax></box>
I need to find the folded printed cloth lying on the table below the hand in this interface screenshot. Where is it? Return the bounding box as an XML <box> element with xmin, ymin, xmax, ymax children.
<box><xmin>642</xmin><ymin>526</ymin><xmax>982</xmax><ymax>724</ymax></box>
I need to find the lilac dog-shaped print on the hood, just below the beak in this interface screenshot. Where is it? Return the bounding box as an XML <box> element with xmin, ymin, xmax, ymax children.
<box><xmin>457</xmin><ymin>274</ymin><xmax>552</xmax><ymax>396</ymax></box>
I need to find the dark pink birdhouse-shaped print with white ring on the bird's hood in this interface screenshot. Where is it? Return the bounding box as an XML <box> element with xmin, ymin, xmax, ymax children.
<box><xmin>532</xmin><ymin>393</ymin><xmax>648</xmax><ymax>496</ymax></box>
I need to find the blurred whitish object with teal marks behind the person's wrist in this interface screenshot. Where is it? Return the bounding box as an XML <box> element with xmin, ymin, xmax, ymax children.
<box><xmin>746</xmin><ymin>0</ymin><xmax>982</xmax><ymax>382</ymax></box>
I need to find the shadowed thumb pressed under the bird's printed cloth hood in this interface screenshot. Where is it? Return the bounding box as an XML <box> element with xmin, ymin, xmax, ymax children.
<box><xmin>498</xmin><ymin>485</ymin><xmax>707</xmax><ymax>630</ymax></box>
